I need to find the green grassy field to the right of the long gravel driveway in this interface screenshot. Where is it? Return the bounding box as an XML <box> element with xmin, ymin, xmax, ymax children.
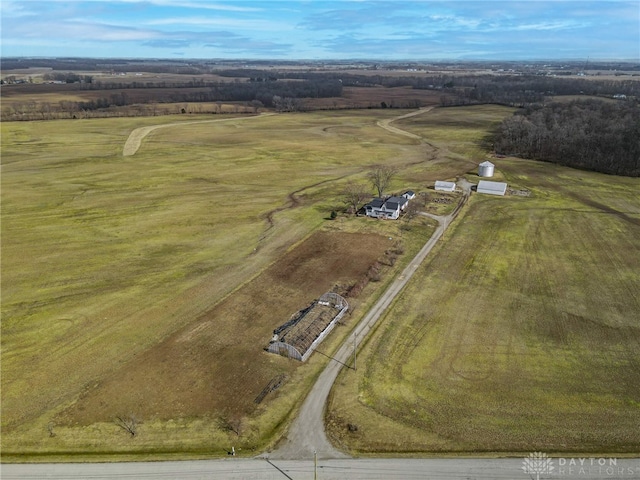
<box><xmin>327</xmin><ymin>153</ymin><xmax>640</xmax><ymax>455</ymax></box>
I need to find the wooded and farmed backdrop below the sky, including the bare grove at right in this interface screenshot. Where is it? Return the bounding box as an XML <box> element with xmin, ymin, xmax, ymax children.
<box><xmin>1</xmin><ymin>59</ymin><xmax>640</xmax><ymax>176</ymax></box>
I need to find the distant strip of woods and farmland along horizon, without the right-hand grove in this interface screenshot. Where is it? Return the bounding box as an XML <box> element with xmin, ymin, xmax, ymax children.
<box><xmin>0</xmin><ymin>58</ymin><xmax>640</xmax><ymax>121</ymax></box>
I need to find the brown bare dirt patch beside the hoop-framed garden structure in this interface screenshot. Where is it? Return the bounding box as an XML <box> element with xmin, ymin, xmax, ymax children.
<box><xmin>59</xmin><ymin>232</ymin><xmax>391</xmax><ymax>424</ymax></box>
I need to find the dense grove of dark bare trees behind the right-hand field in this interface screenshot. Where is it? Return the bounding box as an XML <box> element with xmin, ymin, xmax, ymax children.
<box><xmin>493</xmin><ymin>100</ymin><xmax>640</xmax><ymax>177</ymax></box>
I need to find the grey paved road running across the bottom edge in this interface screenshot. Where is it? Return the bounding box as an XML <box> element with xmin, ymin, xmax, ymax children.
<box><xmin>5</xmin><ymin>458</ymin><xmax>640</xmax><ymax>480</ymax></box>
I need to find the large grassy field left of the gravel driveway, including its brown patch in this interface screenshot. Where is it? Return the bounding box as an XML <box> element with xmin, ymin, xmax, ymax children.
<box><xmin>1</xmin><ymin>110</ymin><xmax>440</xmax><ymax>459</ymax></box>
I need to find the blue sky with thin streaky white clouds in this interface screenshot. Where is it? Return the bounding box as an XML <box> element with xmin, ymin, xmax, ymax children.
<box><xmin>0</xmin><ymin>0</ymin><xmax>640</xmax><ymax>61</ymax></box>
